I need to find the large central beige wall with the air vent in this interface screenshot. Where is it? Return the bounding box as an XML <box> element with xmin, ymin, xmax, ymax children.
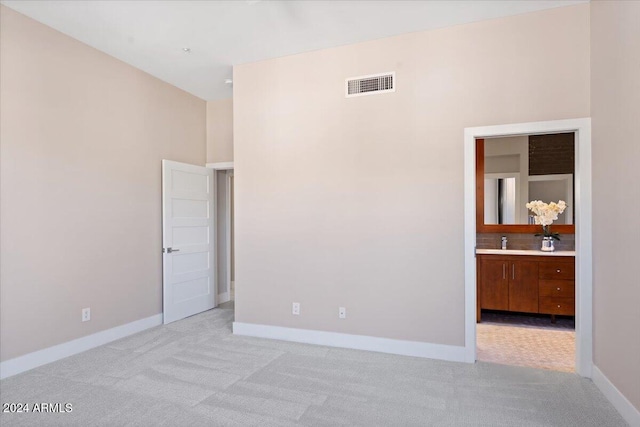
<box><xmin>234</xmin><ymin>4</ymin><xmax>590</xmax><ymax>346</ymax></box>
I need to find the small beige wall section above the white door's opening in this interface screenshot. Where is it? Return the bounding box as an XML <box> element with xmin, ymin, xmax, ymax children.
<box><xmin>207</xmin><ymin>98</ymin><xmax>233</xmax><ymax>163</ymax></box>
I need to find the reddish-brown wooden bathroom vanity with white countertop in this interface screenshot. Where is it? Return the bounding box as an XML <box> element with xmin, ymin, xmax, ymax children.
<box><xmin>476</xmin><ymin>249</ymin><xmax>575</xmax><ymax>322</ymax></box>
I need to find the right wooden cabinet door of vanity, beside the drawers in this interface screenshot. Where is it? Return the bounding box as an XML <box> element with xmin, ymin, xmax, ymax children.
<box><xmin>508</xmin><ymin>261</ymin><xmax>538</xmax><ymax>313</ymax></box>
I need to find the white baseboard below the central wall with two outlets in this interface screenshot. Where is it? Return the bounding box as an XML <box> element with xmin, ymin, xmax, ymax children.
<box><xmin>233</xmin><ymin>322</ymin><xmax>465</xmax><ymax>362</ymax></box>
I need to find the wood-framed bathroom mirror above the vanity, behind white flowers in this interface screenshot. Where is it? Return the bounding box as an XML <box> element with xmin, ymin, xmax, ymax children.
<box><xmin>476</xmin><ymin>133</ymin><xmax>575</xmax><ymax>233</ymax></box>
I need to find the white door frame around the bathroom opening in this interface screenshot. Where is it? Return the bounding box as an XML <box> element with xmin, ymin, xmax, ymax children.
<box><xmin>464</xmin><ymin>118</ymin><xmax>593</xmax><ymax>378</ymax></box>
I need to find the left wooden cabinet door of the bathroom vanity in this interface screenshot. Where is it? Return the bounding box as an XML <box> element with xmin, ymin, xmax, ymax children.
<box><xmin>480</xmin><ymin>258</ymin><xmax>509</xmax><ymax>310</ymax></box>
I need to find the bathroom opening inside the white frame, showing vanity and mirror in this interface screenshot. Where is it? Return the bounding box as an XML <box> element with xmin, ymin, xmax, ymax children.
<box><xmin>476</xmin><ymin>132</ymin><xmax>576</xmax><ymax>372</ymax></box>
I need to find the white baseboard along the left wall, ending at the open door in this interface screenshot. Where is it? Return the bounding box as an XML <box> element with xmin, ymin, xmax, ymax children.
<box><xmin>0</xmin><ymin>313</ymin><xmax>162</xmax><ymax>379</ymax></box>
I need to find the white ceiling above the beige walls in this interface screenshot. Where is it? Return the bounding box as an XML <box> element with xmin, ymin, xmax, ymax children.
<box><xmin>1</xmin><ymin>0</ymin><xmax>588</xmax><ymax>100</ymax></box>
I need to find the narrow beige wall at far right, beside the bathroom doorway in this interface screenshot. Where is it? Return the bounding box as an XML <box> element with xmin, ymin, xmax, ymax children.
<box><xmin>591</xmin><ymin>1</ymin><xmax>640</xmax><ymax>410</ymax></box>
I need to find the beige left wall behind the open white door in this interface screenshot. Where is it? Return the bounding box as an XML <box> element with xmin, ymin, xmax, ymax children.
<box><xmin>0</xmin><ymin>6</ymin><xmax>206</xmax><ymax>360</ymax></box>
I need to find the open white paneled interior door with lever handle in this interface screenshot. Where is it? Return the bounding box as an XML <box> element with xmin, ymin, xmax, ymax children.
<box><xmin>162</xmin><ymin>160</ymin><xmax>216</xmax><ymax>323</ymax></box>
